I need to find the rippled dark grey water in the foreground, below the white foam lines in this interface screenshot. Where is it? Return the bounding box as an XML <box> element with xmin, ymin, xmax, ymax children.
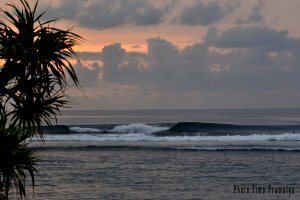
<box><xmin>31</xmin><ymin>142</ymin><xmax>300</xmax><ymax>200</ymax></box>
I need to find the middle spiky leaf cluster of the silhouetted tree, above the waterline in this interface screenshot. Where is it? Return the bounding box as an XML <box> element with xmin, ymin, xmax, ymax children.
<box><xmin>8</xmin><ymin>75</ymin><xmax>68</xmax><ymax>133</ymax></box>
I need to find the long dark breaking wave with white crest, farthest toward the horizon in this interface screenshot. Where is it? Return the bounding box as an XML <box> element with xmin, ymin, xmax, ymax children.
<box><xmin>44</xmin><ymin>122</ymin><xmax>300</xmax><ymax>136</ymax></box>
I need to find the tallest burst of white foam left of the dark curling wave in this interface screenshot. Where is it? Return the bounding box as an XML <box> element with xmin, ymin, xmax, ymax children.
<box><xmin>111</xmin><ymin>124</ymin><xmax>168</xmax><ymax>133</ymax></box>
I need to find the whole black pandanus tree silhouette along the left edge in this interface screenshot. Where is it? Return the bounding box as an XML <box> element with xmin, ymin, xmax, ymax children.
<box><xmin>0</xmin><ymin>0</ymin><xmax>82</xmax><ymax>199</ymax></box>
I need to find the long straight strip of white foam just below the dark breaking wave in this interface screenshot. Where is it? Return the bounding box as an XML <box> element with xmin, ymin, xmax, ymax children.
<box><xmin>44</xmin><ymin>133</ymin><xmax>300</xmax><ymax>142</ymax></box>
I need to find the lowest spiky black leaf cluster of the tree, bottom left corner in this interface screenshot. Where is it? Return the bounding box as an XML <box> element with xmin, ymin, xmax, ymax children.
<box><xmin>0</xmin><ymin>126</ymin><xmax>38</xmax><ymax>198</ymax></box>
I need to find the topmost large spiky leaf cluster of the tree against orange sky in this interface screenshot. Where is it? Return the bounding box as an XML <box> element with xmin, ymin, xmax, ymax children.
<box><xmin>0</xmin><ymin>0</ymin><xmax>81</xmax><ymax>86</ymax></box>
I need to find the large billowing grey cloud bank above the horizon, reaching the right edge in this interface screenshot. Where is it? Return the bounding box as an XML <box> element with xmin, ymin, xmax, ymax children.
<box><xmin>101</xmin><ymin>26</ymin><xmax>300</xmax><ymax>94</ymax></box>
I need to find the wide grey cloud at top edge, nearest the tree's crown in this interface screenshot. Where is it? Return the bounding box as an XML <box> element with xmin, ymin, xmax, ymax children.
<box><xmin>42</xmin><ymin>0</ymin><xmax>168</xmax><ymax>29</ymax></box>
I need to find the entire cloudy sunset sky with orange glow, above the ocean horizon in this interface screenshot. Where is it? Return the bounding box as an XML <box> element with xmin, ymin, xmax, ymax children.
<box><xmin>0</xmin><ymin>0</ymin><xmax>300</xmax><ymax>109</ymax></box>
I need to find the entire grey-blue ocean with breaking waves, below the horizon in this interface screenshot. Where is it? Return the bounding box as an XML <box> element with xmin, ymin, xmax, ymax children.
<box><xmin>31</xmin><ymin>109</ymin><xmax>300</xmax><ymax>200</ymax></box>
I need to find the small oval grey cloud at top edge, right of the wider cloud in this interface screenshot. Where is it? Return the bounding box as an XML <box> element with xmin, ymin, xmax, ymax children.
<box><xmin>179</xmin><ymin>1</ymin><xmax>239</xmax><ymax>26</ymax></box>
